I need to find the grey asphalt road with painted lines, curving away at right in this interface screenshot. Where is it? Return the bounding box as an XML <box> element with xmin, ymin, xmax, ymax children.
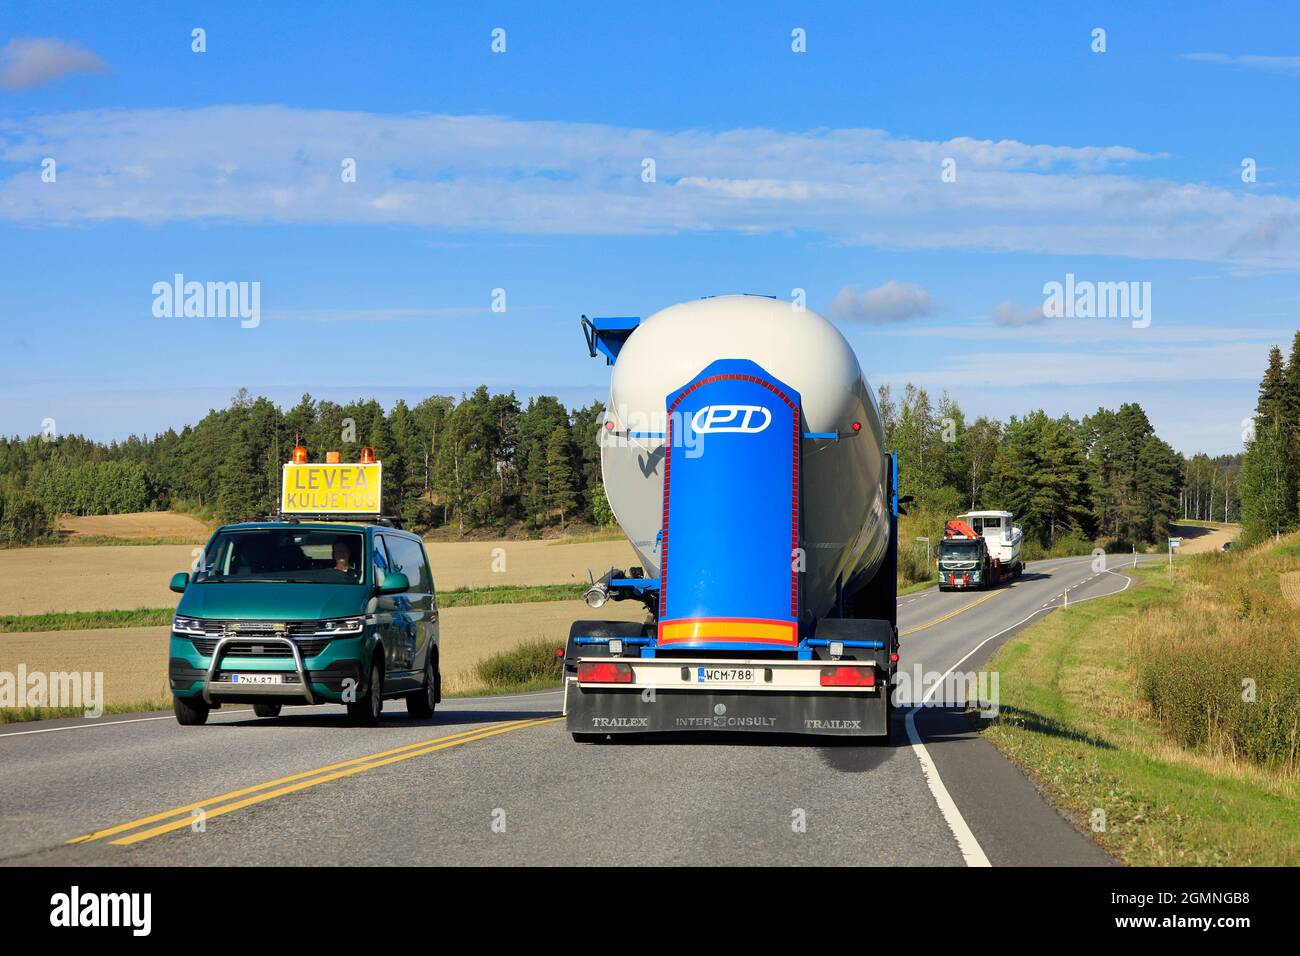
<box><xmin>0</xmin><ymin>548</ymin><xmax>1154</xmax><ymax>866</ymax></box>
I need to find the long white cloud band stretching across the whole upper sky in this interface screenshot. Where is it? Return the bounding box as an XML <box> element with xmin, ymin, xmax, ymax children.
<box><xmin>0</xmin><ymin>107</ymin><xmax>1300</xmax><ymax>269</ymax></box>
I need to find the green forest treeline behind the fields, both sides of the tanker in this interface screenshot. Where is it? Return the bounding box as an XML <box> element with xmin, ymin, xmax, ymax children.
<box><xmin>0</xmin><ymin>371</ymin><xmax>1248</xmax><ymax>553</ymax></box>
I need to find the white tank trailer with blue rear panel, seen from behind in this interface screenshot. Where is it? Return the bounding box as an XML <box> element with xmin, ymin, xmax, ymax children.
<box><xmin>566</xmin><ymin>297</ymin><xmax>898</xmax><ymax>739</ymax></box>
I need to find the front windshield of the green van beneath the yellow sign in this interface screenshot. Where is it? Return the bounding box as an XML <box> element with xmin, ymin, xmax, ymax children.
<box><xmin>194</xmin><ymin>528</ymin><xmax>365</xmax><ymax>584</ymax></box>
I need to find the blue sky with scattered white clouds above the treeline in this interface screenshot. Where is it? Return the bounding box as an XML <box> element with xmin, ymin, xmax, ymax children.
<box><xmin>0</xmin><ymin>3</ymin><xmax>1300</xmax><ymax>453</ymax></box>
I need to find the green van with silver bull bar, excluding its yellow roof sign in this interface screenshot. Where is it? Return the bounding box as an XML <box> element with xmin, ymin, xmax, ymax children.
<box><xmin>168</xmin><ymin>522</ymin><xmax>442</xmax><ymax>724</ymax></box>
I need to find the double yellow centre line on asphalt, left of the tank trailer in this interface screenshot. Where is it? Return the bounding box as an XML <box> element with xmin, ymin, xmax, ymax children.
<box><xmin>68</xmin><ymin>717</ymin><xmax>564</xmax><ymax>847</ymax></box>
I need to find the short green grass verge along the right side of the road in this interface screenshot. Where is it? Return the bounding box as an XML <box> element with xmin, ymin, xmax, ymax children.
<box><xmin>984</xmin><ymin>555</ymin><xmax>1300</xmax><ymax>865</ymax></box>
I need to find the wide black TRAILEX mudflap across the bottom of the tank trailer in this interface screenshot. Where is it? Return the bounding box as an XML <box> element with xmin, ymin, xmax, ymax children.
<box><xmin>566</xmin><ymin>680</ymin><xmax>889</xmax><ymax>737</ymax></box>
